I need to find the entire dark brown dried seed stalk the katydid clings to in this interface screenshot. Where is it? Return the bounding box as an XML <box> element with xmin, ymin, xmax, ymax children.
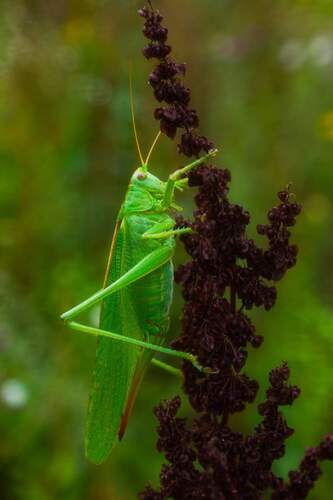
<box><xmin>139</xmin><ymin>5</ymin><xmax>333</xmax><ymax>500</ymax></box>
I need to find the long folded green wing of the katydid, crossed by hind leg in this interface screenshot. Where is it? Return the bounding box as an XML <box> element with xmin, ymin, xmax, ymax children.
<box><xmin>85</xmin><ymin>222</ymin><xmax>140</xmax><ymax>464</ymax></box>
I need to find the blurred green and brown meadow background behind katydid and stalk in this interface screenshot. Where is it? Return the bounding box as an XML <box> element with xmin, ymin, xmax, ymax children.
<box><xmin>0</xmin><ymin>0</ymin><xmax>333</xmax><ymax>500</ymax></box>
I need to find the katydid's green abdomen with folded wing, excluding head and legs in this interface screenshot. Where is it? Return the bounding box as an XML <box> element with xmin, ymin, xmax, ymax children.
<box><xmin>86</xmin><ymin>209</ymin><xmax>175</xmax><ymax>463</ymax></box>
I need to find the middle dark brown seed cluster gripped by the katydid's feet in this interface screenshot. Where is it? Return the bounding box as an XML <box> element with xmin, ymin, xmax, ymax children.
<box><xmin>173</xmin><ymin>178</ymin><xmax>300</xmax><ymax>416</ymax></box>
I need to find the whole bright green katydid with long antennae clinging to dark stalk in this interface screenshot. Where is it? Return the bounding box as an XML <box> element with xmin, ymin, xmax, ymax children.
<box><xmin>61</xmin><ymin>87</ymin><xmax>217</xmax><ymax>464</ymax></box>
